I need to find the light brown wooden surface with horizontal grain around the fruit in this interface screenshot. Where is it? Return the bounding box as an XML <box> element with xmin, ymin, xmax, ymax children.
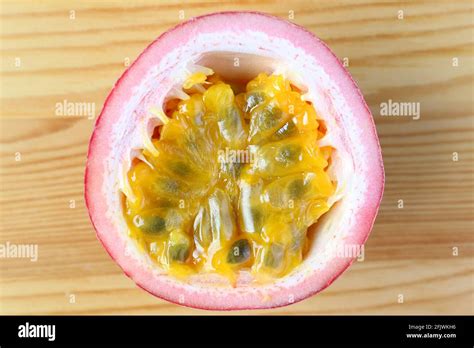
<box><xmin>0</xmin><ymin>0</ymin><xmax>474</xmax><ymax>314</ymax></box>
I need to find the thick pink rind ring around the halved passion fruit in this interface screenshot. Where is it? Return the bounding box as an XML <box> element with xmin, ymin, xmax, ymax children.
<box><xmin>85</xmin><ymin>12</ymin><xmax>384</xmax><ymax>310</ymax></box>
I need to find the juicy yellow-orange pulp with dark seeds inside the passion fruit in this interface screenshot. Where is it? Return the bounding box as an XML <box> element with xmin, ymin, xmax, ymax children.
<box><xmin>124</xmin><ymin>73</ymin><xmax>335</xmax><ymax>282</ymax></box>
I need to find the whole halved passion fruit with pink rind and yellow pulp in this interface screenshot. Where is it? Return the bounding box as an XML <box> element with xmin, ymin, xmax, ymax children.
<box><xmin>85</xmin><ymin>12</ymin><xmax>384</xmax><ymax>309</ymax></box>
